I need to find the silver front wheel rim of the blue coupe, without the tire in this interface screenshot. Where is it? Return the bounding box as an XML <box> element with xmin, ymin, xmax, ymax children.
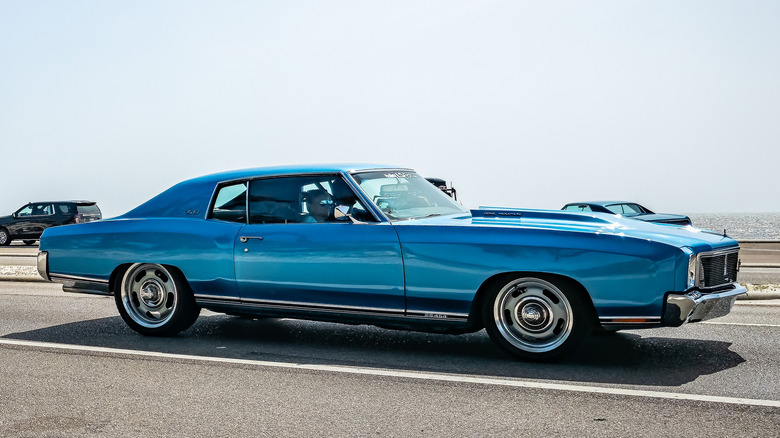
<box><xmin>493</xmin><ymin>278</ymin><xmax>574</xmax><ymax>353</ymax></box>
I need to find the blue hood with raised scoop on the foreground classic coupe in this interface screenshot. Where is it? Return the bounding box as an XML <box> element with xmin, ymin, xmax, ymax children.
<box><xmin>408</xmin><ymin>207</ymin><xmax>738</xmax><ymax>252</ymax></box>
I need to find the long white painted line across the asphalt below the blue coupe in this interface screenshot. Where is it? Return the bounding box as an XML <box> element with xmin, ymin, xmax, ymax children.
<box><xmin>0</xmin><ymin>339</ymin><xmax>780</xmax><ymax>408</ymax></box>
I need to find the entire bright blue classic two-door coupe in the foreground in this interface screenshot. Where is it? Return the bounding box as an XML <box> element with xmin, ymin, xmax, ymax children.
<box><xmin>38</xmin><ymin>165</ymin><xmax>745</xmax><ymax>360</ymax></box>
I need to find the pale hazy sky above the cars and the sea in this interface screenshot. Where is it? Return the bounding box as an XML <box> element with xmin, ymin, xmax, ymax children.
<box><xmin>0</xmin><ymin>0</ymin><xmax>780</xmax><ymax>217</ymax></box>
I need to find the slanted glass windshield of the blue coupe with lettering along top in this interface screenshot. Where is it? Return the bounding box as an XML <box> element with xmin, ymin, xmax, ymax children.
<box><xmin>353</xmin><ymin>171</ymin><xmax>466</xmax><ymax>220</ymax></box>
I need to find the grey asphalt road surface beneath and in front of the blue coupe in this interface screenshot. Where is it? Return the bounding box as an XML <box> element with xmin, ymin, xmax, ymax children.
<box><xmin>0</xmin><ymin>282</ymin><xmax>780</xmax><ymax>437</ymax></box>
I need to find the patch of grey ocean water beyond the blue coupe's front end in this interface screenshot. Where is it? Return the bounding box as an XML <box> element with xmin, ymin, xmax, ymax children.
<box><xmin>688</xmin><ymin>213</ymin><xmax>780</xmax><ymax>240</ymax></box>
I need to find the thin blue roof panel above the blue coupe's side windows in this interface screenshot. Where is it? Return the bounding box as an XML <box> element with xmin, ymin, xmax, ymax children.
<box><xmin>184</xmin><ymin>163</ymin><xmax>412</xmax><ymax>182</ymax></box>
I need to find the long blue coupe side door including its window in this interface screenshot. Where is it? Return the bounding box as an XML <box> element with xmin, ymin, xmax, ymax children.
<box><xmin>234</xmin><ymin>175</ymin><xmax>406</xmax><ymax>313</ymax></box>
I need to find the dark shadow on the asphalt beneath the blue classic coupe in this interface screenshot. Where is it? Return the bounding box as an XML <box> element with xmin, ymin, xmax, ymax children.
<box><xmin>5</xmin><ymin>314</ymin><xmax>745</xmax><ymax>387</ymax></box>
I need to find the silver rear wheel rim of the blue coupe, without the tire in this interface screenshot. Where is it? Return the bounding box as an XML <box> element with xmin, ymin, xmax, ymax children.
<box><xmin>121</xmin><ymin>263</ymin><xmax>178</xmax><ymax>328</ymax></box>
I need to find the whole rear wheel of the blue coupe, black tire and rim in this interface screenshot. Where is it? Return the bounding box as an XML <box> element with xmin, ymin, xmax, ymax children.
<box><xmin>114</xmin><ymin>263</ymin><xmax>200</xmax><ymax>336</ymax></box>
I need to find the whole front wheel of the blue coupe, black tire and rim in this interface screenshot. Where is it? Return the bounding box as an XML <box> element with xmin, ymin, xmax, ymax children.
<box><xmin>482</xmin><ymin>277</ymin><xmax>593</xmax><ymax>361</ymax></box>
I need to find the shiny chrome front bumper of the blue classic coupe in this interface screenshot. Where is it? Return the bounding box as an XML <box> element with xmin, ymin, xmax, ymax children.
<box><xmin>662</xmin><ymin>282</ymin><xmax>747</xmax><ymax>327</ymax></box>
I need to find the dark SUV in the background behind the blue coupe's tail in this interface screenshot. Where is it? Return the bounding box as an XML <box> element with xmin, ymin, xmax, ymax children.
<box><xmin>0</xmin><ymin>201</ymin><xmax>103</xmax><ymax>246</ymax></box>
